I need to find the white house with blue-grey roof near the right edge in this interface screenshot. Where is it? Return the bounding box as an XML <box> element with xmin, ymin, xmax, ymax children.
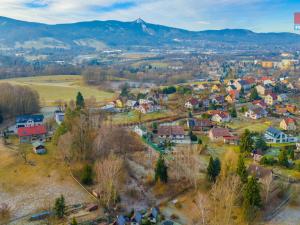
<box><xmin>264</xmin><ymin>127</ymin><xmax>297</xmax><ymax>143</ymax></box>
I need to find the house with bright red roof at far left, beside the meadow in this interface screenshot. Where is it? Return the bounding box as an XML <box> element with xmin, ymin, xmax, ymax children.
<box><xmin>18</xmin><ymin>125</ymin><xmax>47</xmax><ymax>143</ymax></box>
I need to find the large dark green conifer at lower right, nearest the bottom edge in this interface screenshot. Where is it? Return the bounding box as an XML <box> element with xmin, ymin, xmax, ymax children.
<box><xmin>243</xmin><ymin>176</ymin><xmax>261</xmax><ymax>222</ymax></box>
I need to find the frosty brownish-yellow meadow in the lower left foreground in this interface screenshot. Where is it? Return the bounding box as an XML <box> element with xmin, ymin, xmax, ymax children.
<box><xmin>0</xmin><ymin>140</ymin><xmax>93</xmax><ymax>221</ymax></box>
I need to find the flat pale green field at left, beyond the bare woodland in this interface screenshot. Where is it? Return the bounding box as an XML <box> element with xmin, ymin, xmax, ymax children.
<box><xmin>0</xmin><ymin>75</ymin><xmax>114</xmax><ymax>106</ymax></box>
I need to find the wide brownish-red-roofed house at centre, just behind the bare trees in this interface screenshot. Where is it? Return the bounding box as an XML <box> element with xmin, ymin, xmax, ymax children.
<box><xmin>157</xmin><ymin>125</ymin><xmax>184</xmax><ymax>142</ymax></box>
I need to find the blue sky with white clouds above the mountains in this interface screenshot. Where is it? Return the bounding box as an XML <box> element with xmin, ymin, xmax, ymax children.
<box><xmin>0</xmin><ymin>0</ymin><xmax>300</xmax><ymax>33</ymax></box>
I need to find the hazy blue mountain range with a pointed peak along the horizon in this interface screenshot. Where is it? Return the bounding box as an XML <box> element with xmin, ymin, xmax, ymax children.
<box><xmin>0</xmin><ymin>17</ymin><xmax>300</xmax><ymax>50</ymax></box>
